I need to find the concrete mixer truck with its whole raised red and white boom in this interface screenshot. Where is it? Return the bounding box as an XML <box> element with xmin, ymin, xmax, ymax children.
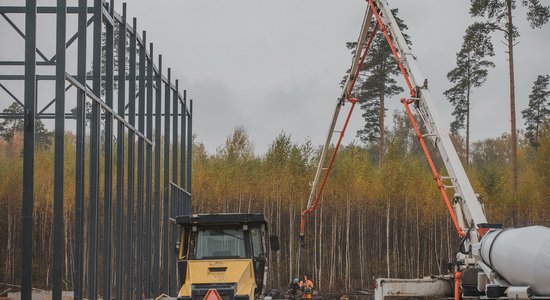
<box><xmin>301</xmin><ymin>0</ymin><xmax>550</xmax><ymax>300</ymax></box>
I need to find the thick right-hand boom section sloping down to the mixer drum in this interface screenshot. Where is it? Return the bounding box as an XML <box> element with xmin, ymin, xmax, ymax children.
<box><xmin>367</xmin><ymin>0</ymin><xmax>487</xmax><ymax>242</ymax></box>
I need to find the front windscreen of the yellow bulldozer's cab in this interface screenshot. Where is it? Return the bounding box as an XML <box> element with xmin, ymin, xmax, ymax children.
<box><xmin>195</xmin><ymin>228</ymin><xmax>246</xmax><ymax>259</ymax></box>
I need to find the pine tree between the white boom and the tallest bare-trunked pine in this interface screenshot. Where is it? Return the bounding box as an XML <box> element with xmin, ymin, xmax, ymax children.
<box><xmin>444</xmin><ymin>23</ymin><xmax>495</xmax><ymax>162</ymax></box>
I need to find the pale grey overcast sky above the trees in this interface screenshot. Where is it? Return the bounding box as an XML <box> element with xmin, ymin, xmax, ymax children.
<box><xmin>0</xmin><ymin>0</ymin><xmax>550</xmax><ymax>153</ymax></box>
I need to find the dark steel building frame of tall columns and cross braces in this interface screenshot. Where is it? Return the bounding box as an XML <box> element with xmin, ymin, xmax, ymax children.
<box><xmin>0</xmin><ymin>0</ymin><xmax>193</xmax><ymax>299</ymax></box>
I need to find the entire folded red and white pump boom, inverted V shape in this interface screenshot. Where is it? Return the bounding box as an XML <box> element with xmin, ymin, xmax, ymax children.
<box><xmin>300</xmin><ymin>0</ymin><xmax>487</xmax><ymax>243</ymax></box>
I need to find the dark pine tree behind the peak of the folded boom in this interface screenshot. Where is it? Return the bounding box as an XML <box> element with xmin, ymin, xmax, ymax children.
<box><xmin>347</xmin><ymin>9</ymin><xmax>410</xmax><ymax>163</ymax></box>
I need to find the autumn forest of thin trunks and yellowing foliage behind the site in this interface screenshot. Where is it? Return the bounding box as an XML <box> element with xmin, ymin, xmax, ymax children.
<box><xmin>0</xmin><ymin>112</ymin><xmax>550</xmax><ymax>292</ymax></box>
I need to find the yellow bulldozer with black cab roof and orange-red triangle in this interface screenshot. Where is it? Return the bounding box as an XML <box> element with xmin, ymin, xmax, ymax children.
<box><xmin>176</xmin><ymin>214</ymin><xmax>279</xmax><ymax>299</ymax></box>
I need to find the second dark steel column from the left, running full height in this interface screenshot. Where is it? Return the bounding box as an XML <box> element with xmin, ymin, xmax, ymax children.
<box><xmin>52</xmin><ymin>0</ymin><xmax>67</xmax><ymax>300</ymax></box>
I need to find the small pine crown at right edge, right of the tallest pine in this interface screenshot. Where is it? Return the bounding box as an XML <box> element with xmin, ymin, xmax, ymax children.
<box><xmin>521</xmin><ymin>75</ymin><xmax>550</xmax><ymax>148</ymax></box>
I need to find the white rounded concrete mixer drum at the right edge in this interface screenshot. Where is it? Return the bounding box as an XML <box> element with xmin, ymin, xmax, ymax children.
<box><xmin>481</xmin><ymin>226</ymin><xmax>550</xmax><ymax>296</ymax></box>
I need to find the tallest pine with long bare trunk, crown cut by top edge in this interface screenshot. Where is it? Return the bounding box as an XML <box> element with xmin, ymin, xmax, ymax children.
<box><xmin>470</xmin><ymin>0</ymin><xmax>550</xmax><ymax>191</ymax></box>
